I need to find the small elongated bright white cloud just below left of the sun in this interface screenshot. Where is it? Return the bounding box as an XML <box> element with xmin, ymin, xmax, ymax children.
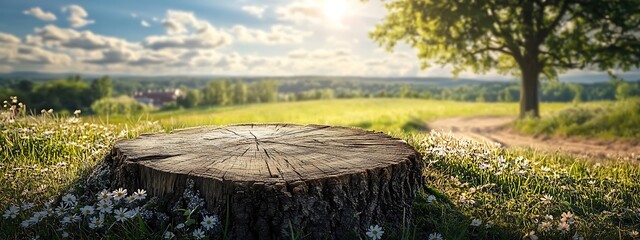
<box><xmin>230</xmin><ymin>25</ymin><xmax>313</xmax><ymax>44</ymax></box>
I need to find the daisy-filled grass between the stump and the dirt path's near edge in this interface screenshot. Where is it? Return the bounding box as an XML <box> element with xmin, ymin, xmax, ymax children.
<box><xmin>411</xmin><ymin>133</ymin><xmax>640</xmax><ymax>239</ymax></box>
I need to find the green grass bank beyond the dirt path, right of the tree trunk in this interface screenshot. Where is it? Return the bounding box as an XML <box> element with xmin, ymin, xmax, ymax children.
<box><xmin>514</xmin><ymin>99</ymin><xmax>640</xmax><ymax>140</ymax></box>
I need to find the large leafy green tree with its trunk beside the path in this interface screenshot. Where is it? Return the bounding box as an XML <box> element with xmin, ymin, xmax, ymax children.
<box><xmin>371</xmin><ymin>0</ymin><xmax>640</xmax><ymax>117</ymax></box>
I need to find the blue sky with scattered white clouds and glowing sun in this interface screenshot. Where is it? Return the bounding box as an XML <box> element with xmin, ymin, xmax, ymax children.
<box><xmin>0</xmin><ymin>0</ymin><xmax>636</xmax><ymax>79</ymax></box>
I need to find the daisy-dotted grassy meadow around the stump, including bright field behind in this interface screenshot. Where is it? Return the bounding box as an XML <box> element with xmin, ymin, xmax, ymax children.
<box><xmin>0</xmin><ymin>99</ymin><xmax>640</xmax><ymax>239</ymax></box>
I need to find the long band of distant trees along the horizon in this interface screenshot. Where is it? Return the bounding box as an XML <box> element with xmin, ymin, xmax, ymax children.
<box><xmin>0</xmin><ymin>76</ymin><xmax>640</xmax><ymax>114</ymax></box>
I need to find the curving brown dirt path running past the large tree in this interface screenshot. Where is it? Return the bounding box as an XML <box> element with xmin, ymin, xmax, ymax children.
<box><xmin>427</xmin><ymin>117</ymin><xmax>640</xmax><ymax>160</ymax></box>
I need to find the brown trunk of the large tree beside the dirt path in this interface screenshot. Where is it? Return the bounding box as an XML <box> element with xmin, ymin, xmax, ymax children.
<box><xmin>520</xmin><ymin>67</ymin><xmax>540</xmax><ymax>118</ymax></box>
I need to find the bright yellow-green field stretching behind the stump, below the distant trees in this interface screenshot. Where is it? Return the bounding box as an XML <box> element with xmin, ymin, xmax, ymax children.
<box><xmin>90</xmin><ymin>98</ymin><xmax>569</xmax><ymax>132</ymax></box>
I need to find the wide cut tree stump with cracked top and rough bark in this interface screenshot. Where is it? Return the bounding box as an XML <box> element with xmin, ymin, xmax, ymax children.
<box><xmin>108</xmin><ymin>124</ymin><xmax>422</xmax><ymax>239</ymax></box>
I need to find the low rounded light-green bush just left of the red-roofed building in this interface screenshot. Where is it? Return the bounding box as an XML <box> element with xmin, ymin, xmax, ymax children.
<box><xmin>91</xmin><ymin>96</ymin><xmax>151</xmax><ymax>116</ymax></box>
